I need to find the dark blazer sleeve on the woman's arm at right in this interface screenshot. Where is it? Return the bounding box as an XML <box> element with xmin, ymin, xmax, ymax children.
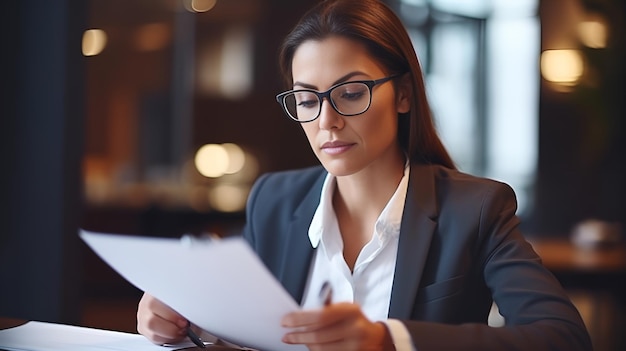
<box><xmin>402</xmin><ymin>182</ymin><xmax>592</xmax><ymax>351</ymax></box>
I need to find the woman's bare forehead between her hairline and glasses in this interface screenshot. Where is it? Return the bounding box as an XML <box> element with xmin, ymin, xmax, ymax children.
<box><xmin>292</xmin><ymin>36</ymin><xmax>385</xmax><ymax>89</ymax></box>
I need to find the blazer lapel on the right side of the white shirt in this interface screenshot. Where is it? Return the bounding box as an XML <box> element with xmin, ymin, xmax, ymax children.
<box><xmin>389</xmin><ymin>165</ymin><xmax>437</xmax><ymax>319</ymax></box>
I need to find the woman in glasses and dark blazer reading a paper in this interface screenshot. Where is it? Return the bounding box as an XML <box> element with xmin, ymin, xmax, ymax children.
<box><xmin>138</xmin><ymin>0</ymin><xmax>591</xmax><ymax>351</ymax></box>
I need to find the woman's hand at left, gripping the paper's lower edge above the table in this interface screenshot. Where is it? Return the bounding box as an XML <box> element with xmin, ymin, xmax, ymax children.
<box><xmin>137</xmin><ymin>293</ymin><xmax>187</xmax><ymax>345</ymax></box>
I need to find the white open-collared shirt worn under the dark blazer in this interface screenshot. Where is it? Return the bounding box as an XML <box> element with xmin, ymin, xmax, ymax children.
<box><xmin>302</xmin><ymin>164</ymin><xmax>415</xmax><ymax>351</ymax></box>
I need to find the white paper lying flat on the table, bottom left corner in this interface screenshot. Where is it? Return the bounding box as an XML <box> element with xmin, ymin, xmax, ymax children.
<box><xmin>0</xmin><ymin>321</ymin><xmax>185</xmax><ymax>351</ymax></box>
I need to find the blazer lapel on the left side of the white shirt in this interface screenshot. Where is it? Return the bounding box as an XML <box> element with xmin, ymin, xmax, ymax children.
<box><xmin>279</xmin><ymin>172</ymin><xmax>326</xmax><ymax>303</ymax></box>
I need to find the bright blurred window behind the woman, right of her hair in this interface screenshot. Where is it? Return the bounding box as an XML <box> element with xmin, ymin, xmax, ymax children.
<box><xmin>394</xmin><ymin>0</ymin><xmax>540</xmax><ymax>214</ymax></box>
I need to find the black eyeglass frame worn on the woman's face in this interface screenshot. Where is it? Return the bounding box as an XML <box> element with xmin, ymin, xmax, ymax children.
<box><xmin>276</xmin><ymin>74</ymin><xmax>400</xmax><ymax>123</ymax></box>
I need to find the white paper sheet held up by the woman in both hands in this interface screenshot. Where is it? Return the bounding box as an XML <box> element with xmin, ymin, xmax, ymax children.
<box><xmin>80</xmin><ymin>230</ymin><xmax>306</xmax><ymax>351</ymax></box>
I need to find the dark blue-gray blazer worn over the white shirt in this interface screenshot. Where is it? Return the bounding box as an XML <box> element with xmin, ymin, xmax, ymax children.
<box><xmin>244</xmin><ymin>165</ymin><xmax>592</xmax><ymax>351</ymax></box>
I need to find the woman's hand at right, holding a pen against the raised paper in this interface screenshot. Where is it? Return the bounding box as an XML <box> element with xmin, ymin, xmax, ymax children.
<box><xmin>282</xmin><ymin>303</ymin><xmax>394</xmax><ymax>351</ymax></box>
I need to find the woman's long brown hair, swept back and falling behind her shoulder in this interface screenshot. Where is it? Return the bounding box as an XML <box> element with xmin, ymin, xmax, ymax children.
<box><xmin>279</xmin><ymin>0</ymin><xmax>456</xmax><ymax>169</ymax></box>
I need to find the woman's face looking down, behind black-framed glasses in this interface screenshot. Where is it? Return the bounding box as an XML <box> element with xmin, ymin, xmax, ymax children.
<box><xmin>292</xmin><ymin>36</ymin><xmax>410</xmax><ymax>176</ymax></box>
